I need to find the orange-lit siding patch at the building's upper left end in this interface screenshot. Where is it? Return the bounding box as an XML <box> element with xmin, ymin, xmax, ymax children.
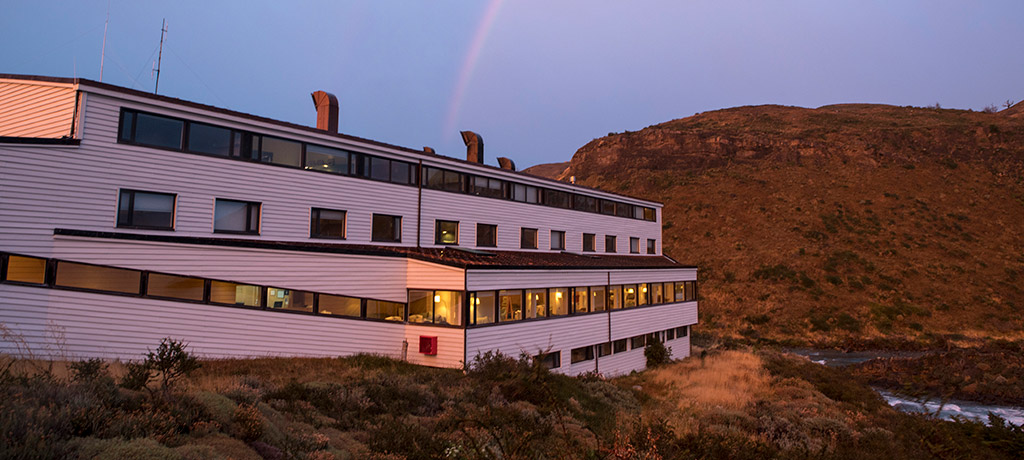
<box><xmin>0</xmin><ymin>79</ymin><xmax>75</xmax><ymax>138</ymax></box>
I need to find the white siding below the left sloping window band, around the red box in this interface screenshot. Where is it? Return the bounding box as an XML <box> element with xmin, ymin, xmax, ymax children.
<box><xmin>0</xmin><ymin>285</ymin><xmax>463</xmax><ymax>368</ymax></box>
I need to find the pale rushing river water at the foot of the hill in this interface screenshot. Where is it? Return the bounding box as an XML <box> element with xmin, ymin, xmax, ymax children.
<box><xmin>786</xmin><ymin>348</ymin><xmax>1024</xmax><ymax>425</ymax></box>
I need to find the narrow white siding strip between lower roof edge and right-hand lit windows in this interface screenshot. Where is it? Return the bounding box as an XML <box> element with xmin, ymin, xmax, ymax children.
<box><xmin>466</xmin><ymin>268</ymin><xmax>696</xmax><ymax>291</ymax></box>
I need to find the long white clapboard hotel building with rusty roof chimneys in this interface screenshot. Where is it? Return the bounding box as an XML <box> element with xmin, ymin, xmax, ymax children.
<box><xmin>0</xmin><ymin>74</ymin><xmax>697</xmax><ymax>375</ymax></box>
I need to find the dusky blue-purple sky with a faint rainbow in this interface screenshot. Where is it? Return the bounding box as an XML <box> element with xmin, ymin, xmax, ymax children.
<box><xmin>0</xmin><ymin>0</ymin><xmax>1024</xmax><ymax>168</ymax></box>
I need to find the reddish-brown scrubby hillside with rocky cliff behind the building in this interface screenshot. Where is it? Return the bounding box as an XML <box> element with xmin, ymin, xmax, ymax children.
<box><xmin>540</xmin><ymin>104</ymin><xmax>1024</xmax><ymax>347</ymax></box>
